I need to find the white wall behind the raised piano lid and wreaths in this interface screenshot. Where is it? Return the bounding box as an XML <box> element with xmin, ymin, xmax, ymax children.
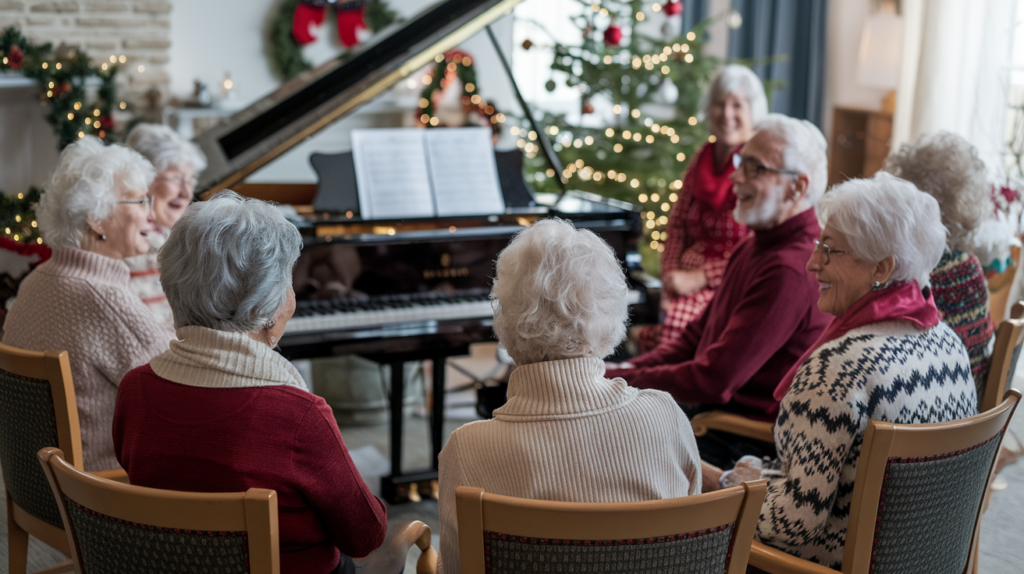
<box><xmin>170</xmin><ymin>0</ymin><xmax>518</xmax><ymax>183</ymax></box>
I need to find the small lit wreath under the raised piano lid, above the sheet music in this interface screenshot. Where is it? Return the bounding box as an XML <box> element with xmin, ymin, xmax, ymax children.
<box><xmin>416</xmin><ymin>50</ymin><xmax>505</xmax><ymax>133</ymax></box>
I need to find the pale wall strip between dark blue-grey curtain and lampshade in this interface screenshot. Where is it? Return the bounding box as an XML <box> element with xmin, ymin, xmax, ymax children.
<box><xmin>823</xmin><ymin>0</ymin><xmax>886</xmax><ymax>138</ymax></box>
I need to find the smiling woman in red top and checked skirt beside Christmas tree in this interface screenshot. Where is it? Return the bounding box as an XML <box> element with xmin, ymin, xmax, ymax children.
<box><xmin>637</xmin><ymin>64</ymin><xmax>768</xmax><ymax>352</ymax></box>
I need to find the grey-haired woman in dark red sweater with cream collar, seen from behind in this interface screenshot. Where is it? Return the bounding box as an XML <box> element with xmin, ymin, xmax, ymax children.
<box><xmin>114</xmin><ymin>191</ymin><xmax>387</xmax><ymax>574</ymax></box>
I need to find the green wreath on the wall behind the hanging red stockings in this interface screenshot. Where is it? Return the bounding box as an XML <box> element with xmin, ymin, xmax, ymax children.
<box><xmin>267</xmin><ymin>0</ymin><xmax>398</xmax><ymax>80</ymax></box>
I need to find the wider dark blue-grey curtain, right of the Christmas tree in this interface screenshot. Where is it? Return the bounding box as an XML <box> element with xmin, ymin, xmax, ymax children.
<box><xmin>729</xmin><ymin>0</ymin><xmax>828</xmax><ymax>127</ymax></box>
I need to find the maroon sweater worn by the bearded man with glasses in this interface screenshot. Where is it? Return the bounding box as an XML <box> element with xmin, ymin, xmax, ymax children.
<box><xmin>605</xmin><ymin>209</ymin><xmax>830</xmax><ymax>418</ymax></box>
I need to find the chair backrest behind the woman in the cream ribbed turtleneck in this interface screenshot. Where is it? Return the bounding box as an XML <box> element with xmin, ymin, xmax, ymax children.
<box><xmin>456</xmin><ymin>481</ymin><xmax>767</xmax><ymax>574</ymax></box>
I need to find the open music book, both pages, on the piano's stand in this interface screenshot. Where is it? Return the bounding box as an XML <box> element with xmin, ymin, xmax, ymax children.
<box><xmin>352</xmin><ymin>128</ymin><xmax>505</xmax><ymax>219</ymax></box>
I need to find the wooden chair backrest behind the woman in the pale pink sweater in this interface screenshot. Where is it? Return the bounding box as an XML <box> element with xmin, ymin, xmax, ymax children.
<box><xmin>0</xmin><ymin>344</ymin><xmax>82</xmax><ymax>536</ymax></box>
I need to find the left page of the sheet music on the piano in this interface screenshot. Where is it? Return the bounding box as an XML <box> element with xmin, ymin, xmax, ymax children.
<box><xmin>352</xmin><ymin>128</ymin><xmax>436</xmax><ymax>219</ymax></box>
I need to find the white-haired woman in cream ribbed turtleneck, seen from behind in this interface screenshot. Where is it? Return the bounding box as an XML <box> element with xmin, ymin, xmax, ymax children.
<box><xmin>438</xmin><ymin>220</ymin><xmax>700</xmax><ymax>573</ymax></box>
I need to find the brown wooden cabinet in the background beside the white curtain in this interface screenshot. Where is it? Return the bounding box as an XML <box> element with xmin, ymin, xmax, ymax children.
<box><xmin>828</xmin><ymin>106</ymin><xmax>893</xmax><ymax>186</ymax></box>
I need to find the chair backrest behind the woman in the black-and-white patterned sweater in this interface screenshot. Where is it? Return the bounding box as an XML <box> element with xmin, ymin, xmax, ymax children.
<box><xmin>843</xmin><ymin>389</ymin><xmax>1021</xmax><ymax>574</ymax></box>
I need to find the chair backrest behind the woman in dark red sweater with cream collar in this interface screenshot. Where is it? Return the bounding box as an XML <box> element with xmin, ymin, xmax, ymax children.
<box><xmin>37</xmin><ymin>448</ymin><xmax>281</xmax><ymax>574</ymax></box>
